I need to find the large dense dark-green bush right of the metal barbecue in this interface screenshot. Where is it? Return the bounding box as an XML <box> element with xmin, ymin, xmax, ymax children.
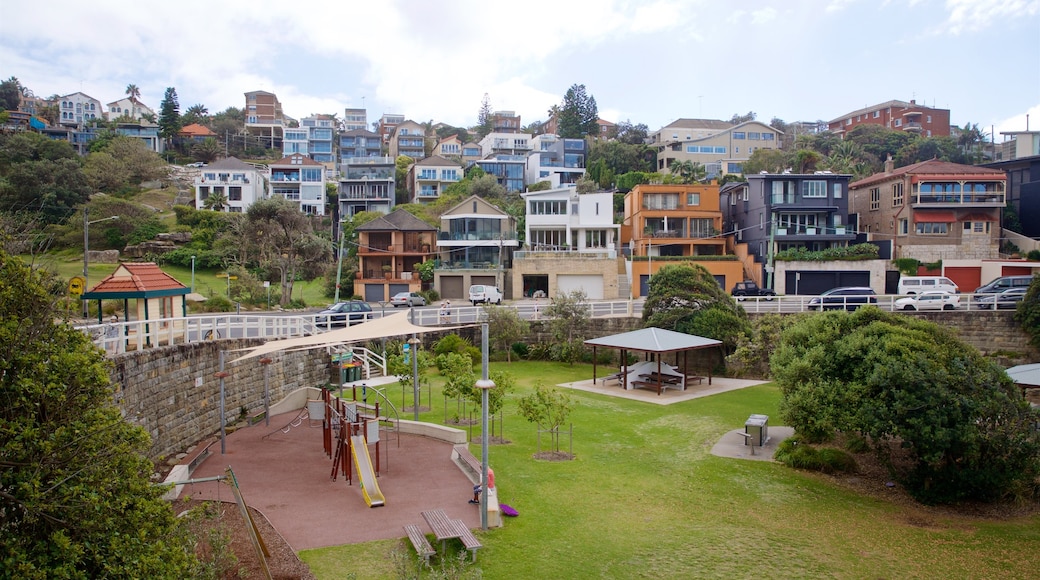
<box><xmin>772</xmin><ymin>308</ymin><xmax>1040</xmax><ymax>503</ymax></box>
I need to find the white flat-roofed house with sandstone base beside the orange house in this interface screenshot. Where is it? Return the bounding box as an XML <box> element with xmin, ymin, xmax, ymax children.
<box><xmin>508</xmin><ymin>187</ymin><xmax>628</xmax><ymax>299</ymax></box>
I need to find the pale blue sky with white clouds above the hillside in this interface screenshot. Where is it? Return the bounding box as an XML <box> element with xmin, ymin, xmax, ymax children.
<box><xmin>0</xmin><ymin>0</ymin><xmax>1040</xmax><ymax>142</ymax></box>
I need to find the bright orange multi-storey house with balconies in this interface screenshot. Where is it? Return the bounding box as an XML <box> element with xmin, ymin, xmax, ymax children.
<box><xmin>621</xmin><ymin>184</ymin><xmax>744</xmax><ymax>298</ymax></box>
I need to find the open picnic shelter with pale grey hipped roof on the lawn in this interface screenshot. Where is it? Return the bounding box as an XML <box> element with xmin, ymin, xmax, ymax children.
<box><xmin>584</xmin><ymin>327</ymin><xmax>722</xmax><ymax>395</ymax></box>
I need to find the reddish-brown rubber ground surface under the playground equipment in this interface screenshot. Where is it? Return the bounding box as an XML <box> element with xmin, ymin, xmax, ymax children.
<box><xmin>181</xmin><ymin>411</ymin><xmax>480</xmax><ymax>552</ymax></box>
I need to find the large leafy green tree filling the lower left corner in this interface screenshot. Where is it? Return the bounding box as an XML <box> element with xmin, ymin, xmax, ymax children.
<box><xmin>0</xmin><ymin>251</ymin><xmax>196</xmax><ymax>578</ymax></box>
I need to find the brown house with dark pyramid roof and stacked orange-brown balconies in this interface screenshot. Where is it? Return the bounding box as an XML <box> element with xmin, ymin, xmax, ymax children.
<box><xmin>354</xmin><ymin>210</ymin><xmax>437</xmax><ymax>302</ymax></box>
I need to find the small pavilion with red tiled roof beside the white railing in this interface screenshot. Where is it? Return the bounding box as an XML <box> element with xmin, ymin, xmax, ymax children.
<box><xmin>80</xmin><ymin>262</ymin><xmax>190</xmax><ymax>338</ymax></box>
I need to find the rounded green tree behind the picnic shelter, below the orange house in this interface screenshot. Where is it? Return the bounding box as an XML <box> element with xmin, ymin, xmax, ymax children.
<box><xmin>643</xmin><ymin>263</ymin><xmax>751</xmax><ymax>352</ymax></box>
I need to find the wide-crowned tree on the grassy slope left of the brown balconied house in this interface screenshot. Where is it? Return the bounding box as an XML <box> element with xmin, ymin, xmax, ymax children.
<box><xmin>245</xmin><ymin>197</ymin><xmax>332</xmax><ymax>307</ymax></box>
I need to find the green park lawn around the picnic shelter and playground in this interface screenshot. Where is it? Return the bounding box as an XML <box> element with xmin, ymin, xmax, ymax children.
<box><xmin>301</xmin><ymin>363</ymin><xmax>1040</xmax><ymax>579</ymax></box>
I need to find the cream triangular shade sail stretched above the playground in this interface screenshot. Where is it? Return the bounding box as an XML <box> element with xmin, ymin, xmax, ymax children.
<box><xmin>231</xmin><ymin>312</ymin><xmax>472</xmax><ymax>363</ymax></box>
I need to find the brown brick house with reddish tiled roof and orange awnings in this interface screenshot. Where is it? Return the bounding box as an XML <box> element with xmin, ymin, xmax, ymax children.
<box><xmin>849</xmin><ymin>158</ymin><xmax>1007</xmax><ymax>263</ymax></box>
